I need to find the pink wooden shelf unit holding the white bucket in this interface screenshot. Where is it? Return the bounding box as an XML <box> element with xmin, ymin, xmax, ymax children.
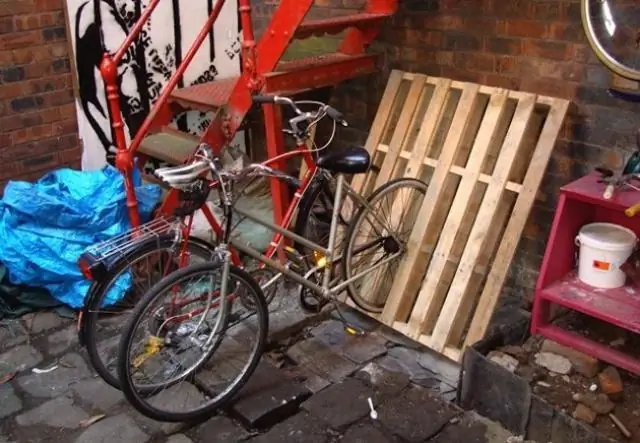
<box><xmin>531</xmin><ymin>173</ymin><xmax>640</xmax><ymax>374</ymax></box>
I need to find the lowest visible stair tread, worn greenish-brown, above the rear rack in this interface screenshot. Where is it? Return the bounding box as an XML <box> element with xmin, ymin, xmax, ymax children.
<box><xmin>139</xmin><ymin>130</ymin><xmax>200</xmax><ymax>165</ymax></box>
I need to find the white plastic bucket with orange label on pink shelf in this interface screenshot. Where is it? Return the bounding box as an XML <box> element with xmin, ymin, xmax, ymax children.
<box><xmin>576</xmin><ymin>223</ymin><xmax>638</xmax><ymax>289</ymax></box>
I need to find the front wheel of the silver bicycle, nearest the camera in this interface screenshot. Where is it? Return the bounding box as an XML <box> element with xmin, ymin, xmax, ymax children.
<box><xmin>118</xmin><ymin>263</ymin><xmax>268</xmax><ymax>422</ymax></box>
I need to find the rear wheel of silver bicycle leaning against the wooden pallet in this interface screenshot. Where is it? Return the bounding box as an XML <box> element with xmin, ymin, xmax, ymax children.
<box><xmin>342</xmin><ymin>178</ymin><xmax>427</xmax><ymax>313</ymax></box>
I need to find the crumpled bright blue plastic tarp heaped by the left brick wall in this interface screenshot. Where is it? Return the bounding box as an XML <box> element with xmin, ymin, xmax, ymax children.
<box><xmin>0</xmin><ymin>166</ymin><xmax>162</xmax><ymax>308</ymax></box>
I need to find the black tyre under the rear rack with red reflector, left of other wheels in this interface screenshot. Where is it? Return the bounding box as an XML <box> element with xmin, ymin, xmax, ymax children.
<box><xmin>82</xmin><ymin>235</ymin><xmax>215</xmax><ymax>389</ymax></box>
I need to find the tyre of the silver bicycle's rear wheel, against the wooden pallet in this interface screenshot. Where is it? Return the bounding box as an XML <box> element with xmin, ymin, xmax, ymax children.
<box><xmin>341</xmin><ymin>178</ymin><xmax>428</xmax><ymax>314</ymax></box>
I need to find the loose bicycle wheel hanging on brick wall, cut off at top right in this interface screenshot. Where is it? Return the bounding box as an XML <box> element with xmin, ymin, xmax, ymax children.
<box><xmin>580</xmin><ymin>0</ymin><xmax>640</xmax><ymax>81</ymax></box>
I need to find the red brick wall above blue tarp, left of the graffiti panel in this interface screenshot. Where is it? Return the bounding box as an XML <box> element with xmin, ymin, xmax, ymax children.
<box><xmin>0</xmin><ymin>0</ymin><xmax>80</xmax><ymax>188</ymax></box>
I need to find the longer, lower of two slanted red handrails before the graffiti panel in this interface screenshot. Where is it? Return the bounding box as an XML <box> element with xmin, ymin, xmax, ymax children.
<box><xmin>129</xmin><ymin>0</ymin><xmax>225</xmax><ymax>158</ymax></box>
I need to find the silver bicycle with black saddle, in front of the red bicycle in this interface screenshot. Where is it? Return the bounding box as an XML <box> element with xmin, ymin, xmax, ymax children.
<box><xmin>118</xmin><ymin>96</ymin><xmax>427</xmax><ymax>421</ymax></box>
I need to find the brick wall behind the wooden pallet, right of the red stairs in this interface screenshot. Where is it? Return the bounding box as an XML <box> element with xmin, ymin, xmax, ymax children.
<box><xmin>254</xmin><ymin>0</ymin><xmax>640</xmax><ymax>308</ymax></box>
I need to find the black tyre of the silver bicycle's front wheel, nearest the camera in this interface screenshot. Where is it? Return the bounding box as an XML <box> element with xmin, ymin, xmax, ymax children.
<box><xmin>118</xmin><ymin>262</ymin><xmax>269</xmax><ymax>422</ymax></box>
